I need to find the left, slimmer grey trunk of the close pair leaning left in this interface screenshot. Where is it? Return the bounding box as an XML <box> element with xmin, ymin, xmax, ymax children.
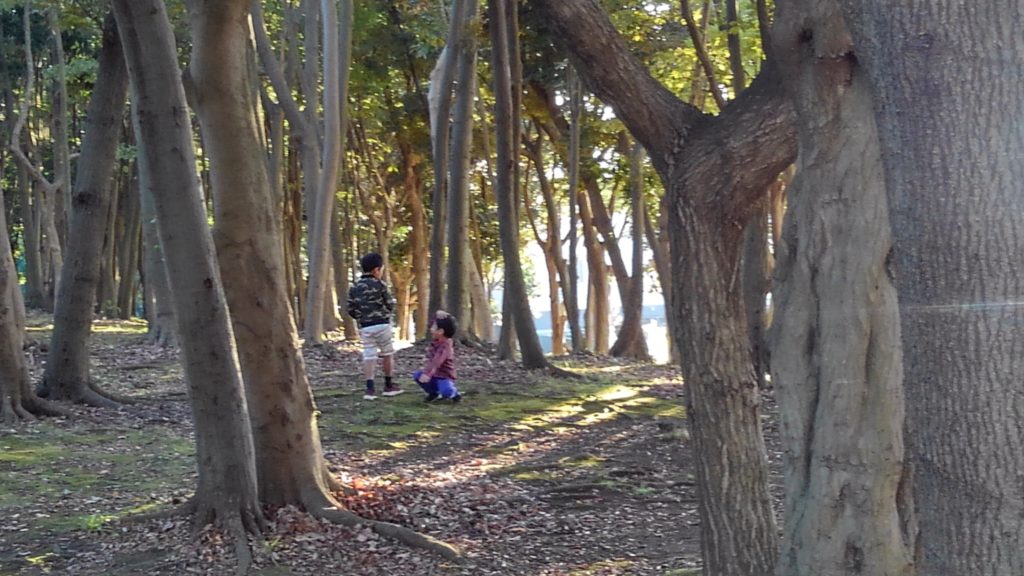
<box><xmin>114</xmin><ymin>0</ymin><xmax>264</xmax><ymax>549</ymax></box>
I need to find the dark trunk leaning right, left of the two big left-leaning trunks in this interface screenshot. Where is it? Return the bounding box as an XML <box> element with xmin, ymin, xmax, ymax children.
<box><xmin>39</xmin><ymin>13</ymin><xmax>128</xmax><ymax>406</ymax></box>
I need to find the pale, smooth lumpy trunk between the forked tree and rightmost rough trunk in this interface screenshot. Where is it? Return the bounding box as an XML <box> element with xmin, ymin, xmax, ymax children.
<box><xmin>762</xmin><ymin>0</ymin><xmax>911</xmax><ymax>576</ymax></box>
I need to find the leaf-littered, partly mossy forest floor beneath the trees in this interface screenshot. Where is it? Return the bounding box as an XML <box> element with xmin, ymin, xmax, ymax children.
<box><xmin>0</xmin><ymin>317</ymin><xmax>777</xmax><ymax>576</ymax></box>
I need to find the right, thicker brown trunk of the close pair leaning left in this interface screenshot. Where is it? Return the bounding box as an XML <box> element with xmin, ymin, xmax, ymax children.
<box><xmin>179</xmin><ymin>0</ymin><xmax>337</xmax><ymax>505</ymax></box>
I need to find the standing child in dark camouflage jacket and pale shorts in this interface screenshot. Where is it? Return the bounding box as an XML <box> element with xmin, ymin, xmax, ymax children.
<box><xmin>348</xmin><ymin>252</ymin><xmax>402</xmax><ymax>400</ymax></box>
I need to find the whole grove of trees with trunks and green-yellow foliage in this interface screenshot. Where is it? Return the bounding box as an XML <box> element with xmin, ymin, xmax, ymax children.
<box><xmin>0</xmin><ymin>0</ymin><xmax>1024</xmax><ymax>576</ymax></box>
